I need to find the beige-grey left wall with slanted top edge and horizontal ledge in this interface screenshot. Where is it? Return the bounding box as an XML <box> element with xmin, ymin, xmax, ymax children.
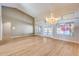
<box><xmin>2</xmin><ymin>7</ymin><xmax>34</xmax><ymax>37</ymax></box>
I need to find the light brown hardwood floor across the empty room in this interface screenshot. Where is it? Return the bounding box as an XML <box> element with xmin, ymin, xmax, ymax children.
<box><xmin>0</xmin><ymin>36</ymin><xmax>79</xmax><ymax>56</ymax></box>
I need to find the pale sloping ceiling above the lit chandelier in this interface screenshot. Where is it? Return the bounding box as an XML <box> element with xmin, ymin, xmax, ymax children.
<box><xmin>21</xmin><ymin>3</ymin><xmax>79</xmax><ymax>17</ymax></box>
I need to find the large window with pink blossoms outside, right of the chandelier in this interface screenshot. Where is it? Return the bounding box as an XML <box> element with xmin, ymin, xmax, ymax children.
<box><xmin>57</xmin><ymin>23</ymin><xmax>73</xmax><ymax>35</ymax></box>
